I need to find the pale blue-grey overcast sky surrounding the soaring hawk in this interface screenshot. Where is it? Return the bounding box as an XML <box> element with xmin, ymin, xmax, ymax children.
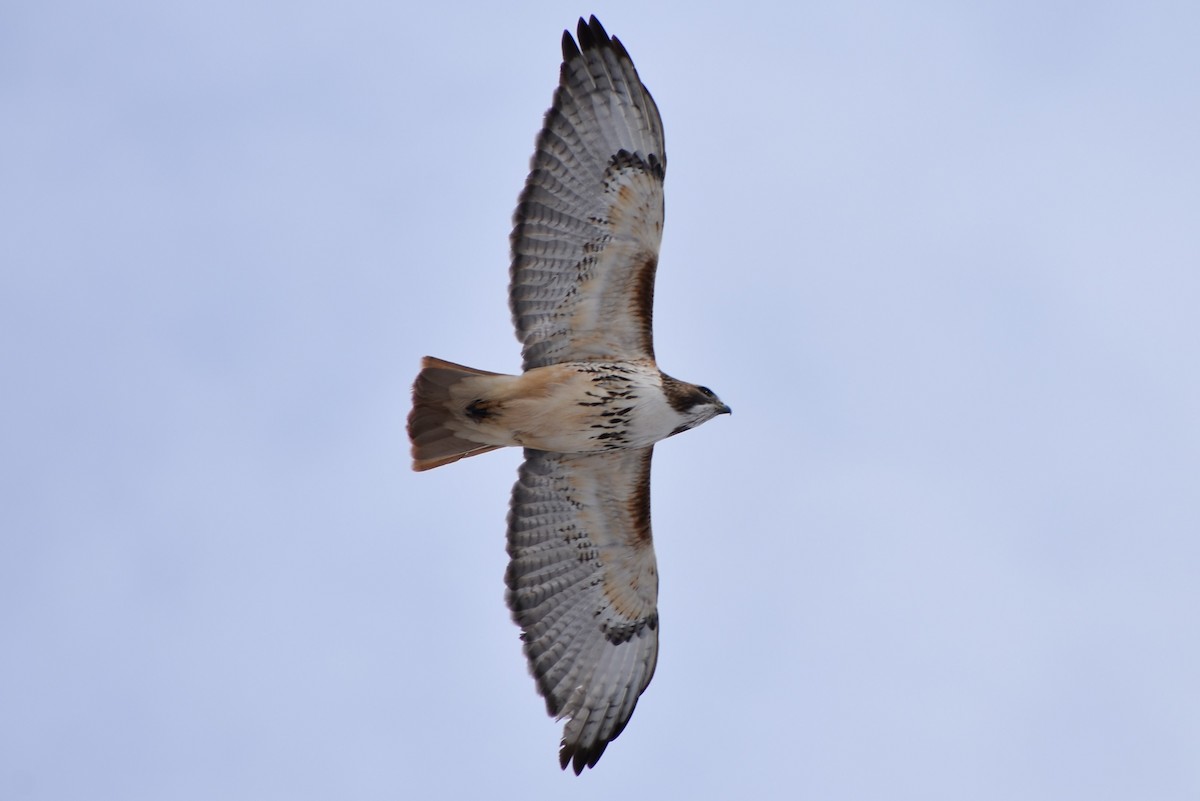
<box><xmin>0</xmin><ymin>0</ymin><xmax>1200</xmax><ymax>801</ymax></box>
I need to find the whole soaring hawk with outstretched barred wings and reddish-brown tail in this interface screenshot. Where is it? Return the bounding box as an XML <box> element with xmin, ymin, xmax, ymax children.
<box><xmin>408</xmin><ymin>17</ymin><xmax>730</xmax><ymax>775</ymax></box>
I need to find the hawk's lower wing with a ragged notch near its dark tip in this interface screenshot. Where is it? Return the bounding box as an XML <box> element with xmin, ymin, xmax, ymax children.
<box><xmin>505</xmin><ymin>447</ymin><xmax>659</xmax><ymax>773</ymax></box>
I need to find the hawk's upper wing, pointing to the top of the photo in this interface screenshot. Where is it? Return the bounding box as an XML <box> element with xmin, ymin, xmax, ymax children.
<box><xmin>509</xmin><ymin>17</ymin><xmax>667</xmax><ymax>369</ymax></box>
